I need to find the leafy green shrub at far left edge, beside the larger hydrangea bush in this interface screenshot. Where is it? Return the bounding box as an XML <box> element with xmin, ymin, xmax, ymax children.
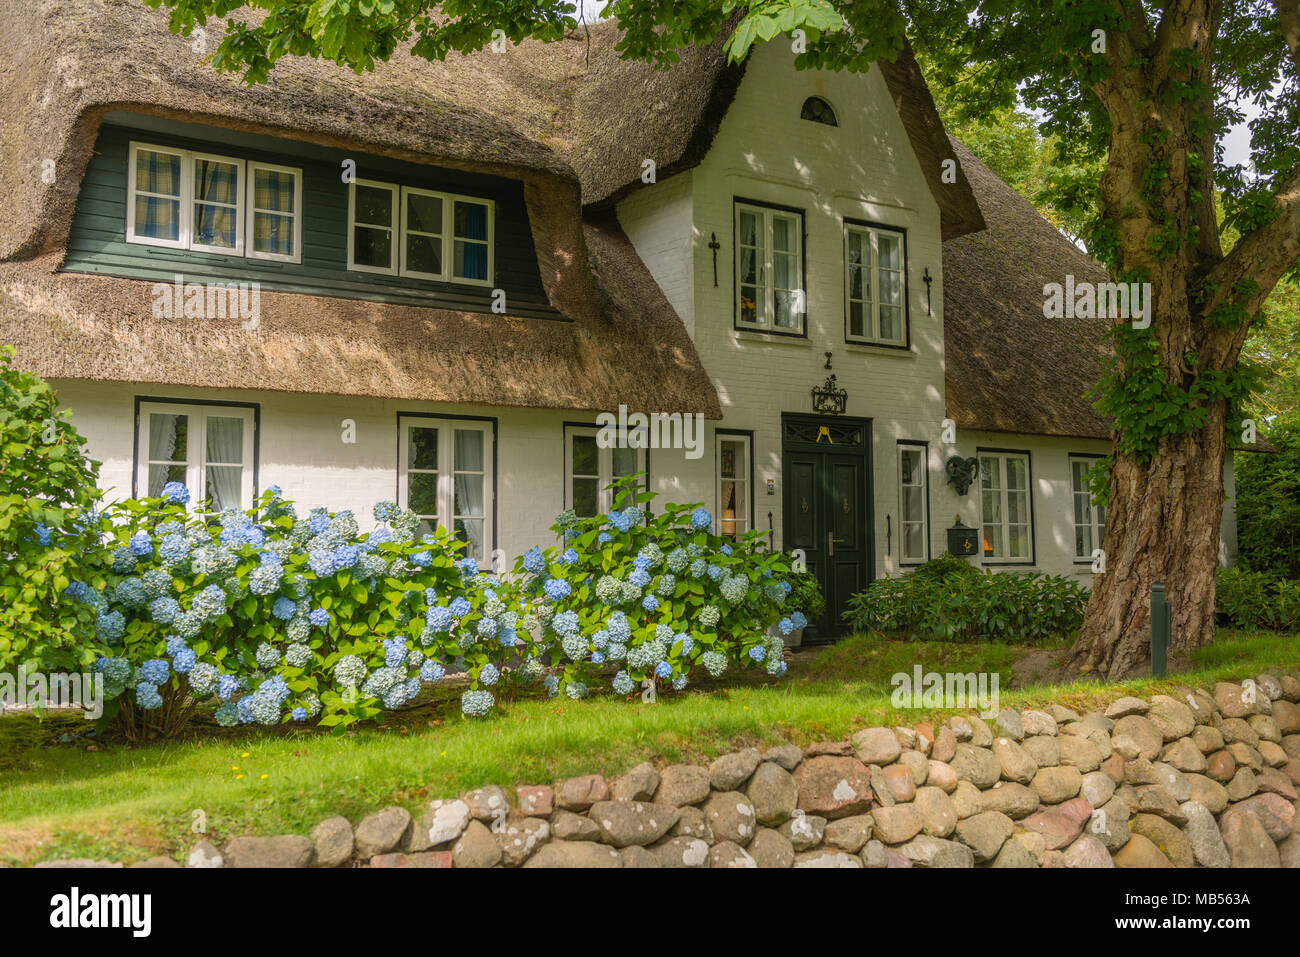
<box><xmin>0</xmin><ymin>347</ymin><xmax>99</xmax><ymax>671</ymax></box>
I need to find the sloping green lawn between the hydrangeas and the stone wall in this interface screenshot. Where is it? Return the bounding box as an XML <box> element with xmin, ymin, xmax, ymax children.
<box><xmin>0</xmin><ymin>631</ymin><xmax>1300</xmax><ymax>863</ymax></box>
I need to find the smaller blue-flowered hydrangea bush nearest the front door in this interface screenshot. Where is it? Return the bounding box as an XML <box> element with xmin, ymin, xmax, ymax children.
<box><xmin>515</xmin><ymin>480</ymin><xmax>806</xmax><ymax>698</ymax></box>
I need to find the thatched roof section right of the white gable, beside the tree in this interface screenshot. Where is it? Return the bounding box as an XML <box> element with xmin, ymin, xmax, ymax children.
<box><xmin>944</xmin><ymin>140</ymin><xmax>1110</xmax><ymax>438</ymax></box>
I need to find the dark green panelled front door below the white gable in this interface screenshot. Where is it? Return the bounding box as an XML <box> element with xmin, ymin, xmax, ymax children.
<box><xmin>781</xmin><ymin>416</ymin><xmax>874</xmax><ymax>640</ymax></box>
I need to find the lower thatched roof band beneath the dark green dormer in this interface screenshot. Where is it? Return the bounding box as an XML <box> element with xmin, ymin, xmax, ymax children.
<box><xmin>0</xmin><ymin>210</ymin><xmax>722</xmax><ymax>419</ymax></box>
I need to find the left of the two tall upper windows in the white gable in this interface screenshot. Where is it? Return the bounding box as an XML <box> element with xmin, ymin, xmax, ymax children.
<box><xmin>736</xmin><ymin>202</ymin><xmax>805</xmax><ymax>335</ymax></box>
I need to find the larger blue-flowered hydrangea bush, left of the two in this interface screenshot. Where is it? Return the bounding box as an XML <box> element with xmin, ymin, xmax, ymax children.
<box><xmin>69</xmin><ymin>482</ymin><xmax>541</xmax><ymax>733</ymax></box>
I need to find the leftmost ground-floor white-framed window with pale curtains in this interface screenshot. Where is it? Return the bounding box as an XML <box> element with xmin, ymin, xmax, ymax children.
<box><xmin>137</xmin><ymin>402</ymin><xmax>256</xmax><ymax>511</ymax></box>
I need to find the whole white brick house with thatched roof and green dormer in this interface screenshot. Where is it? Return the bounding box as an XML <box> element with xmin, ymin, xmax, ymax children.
<box><xmin>0</xmin><ymin>0</ymin><xmax>1235</xmax><ymax>642</ymax></box>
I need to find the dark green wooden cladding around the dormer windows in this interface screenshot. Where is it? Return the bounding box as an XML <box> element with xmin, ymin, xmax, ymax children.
<box><xmin>64</xmin><ymin>112</ymin><xmax>562</xmax><ymax>319</ymax></box>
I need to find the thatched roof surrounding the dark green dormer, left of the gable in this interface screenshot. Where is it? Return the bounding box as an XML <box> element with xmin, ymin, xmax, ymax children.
<box><xmin>0</xmin><ymin>0</ymin><xmax>720</xmax><ymax>417</ymax></box>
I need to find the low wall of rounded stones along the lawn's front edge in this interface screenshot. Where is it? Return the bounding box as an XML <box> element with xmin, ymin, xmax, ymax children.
<box><xmin>35</xmin><ymin>675</ymin><xmax>1300</xmax><ymax>867</ymax></box>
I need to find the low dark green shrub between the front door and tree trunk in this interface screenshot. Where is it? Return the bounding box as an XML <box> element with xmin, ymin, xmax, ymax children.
<box><xmin>845</xmin><ymin>558</ymin><xmax>1088</xmax><ymax>641</ymax></box>
